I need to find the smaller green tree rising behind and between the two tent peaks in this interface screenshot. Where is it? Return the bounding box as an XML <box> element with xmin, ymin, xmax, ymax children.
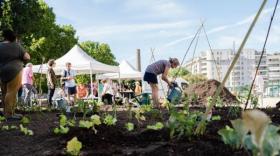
<box><xmin>80</xmin><ymin>41</ymin><xmax>118</xmax><ymax>65</ymax></box>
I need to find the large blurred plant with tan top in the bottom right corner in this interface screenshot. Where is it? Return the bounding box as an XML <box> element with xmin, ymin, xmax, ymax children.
<box><xmin>218</xmin><ymin>110</ymin><xmax>280</xmax><ymax>156</ymax></box>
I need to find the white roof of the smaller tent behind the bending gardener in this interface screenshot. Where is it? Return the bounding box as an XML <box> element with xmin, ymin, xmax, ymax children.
<box><xmin>97</xmin><ymin>60</ymin><xmax>142</xmax><ymax>80</ymax></box>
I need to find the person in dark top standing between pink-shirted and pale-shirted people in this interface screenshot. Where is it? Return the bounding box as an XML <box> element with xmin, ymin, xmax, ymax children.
<box><xmin>47</xmin><ymin>59</ymin><xmax>56</xmax><ymax>107</ymax></box>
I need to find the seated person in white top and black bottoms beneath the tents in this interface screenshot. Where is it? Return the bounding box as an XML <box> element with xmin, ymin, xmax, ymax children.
<box><xmin>101</xmin><ymin>79</ymin><xmax>114</xmax><ymax>105</ymax></box>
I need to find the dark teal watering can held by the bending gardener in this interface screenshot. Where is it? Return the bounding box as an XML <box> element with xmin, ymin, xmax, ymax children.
<box><xmin>167</xmin><ymin>82</ymin><xmax>183</xmax><ymax>104</ymax></box>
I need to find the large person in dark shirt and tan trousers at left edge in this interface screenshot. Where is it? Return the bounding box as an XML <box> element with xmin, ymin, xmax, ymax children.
<box><xmin>0</xmin><ymin>30</ymin><xmax>30</xmax><ymax>119</ymax></box>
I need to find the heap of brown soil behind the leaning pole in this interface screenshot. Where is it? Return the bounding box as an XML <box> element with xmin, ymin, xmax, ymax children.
<box><xmin>184</xmin><ymin>80</ymin><xmax>237</xmax><ymax>104</ymax></box>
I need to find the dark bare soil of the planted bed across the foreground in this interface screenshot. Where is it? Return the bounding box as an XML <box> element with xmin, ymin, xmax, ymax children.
<box><xmin>0</xmin><ymin>108</ymin><xmax>280</xmax><ymax>156</ymax></box>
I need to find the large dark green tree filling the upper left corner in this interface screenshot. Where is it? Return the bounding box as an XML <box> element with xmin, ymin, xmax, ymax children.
<box><xmin>0</xmin><ymin>0</ymin><xmax>78</xmax><ymax>64</ymax></box>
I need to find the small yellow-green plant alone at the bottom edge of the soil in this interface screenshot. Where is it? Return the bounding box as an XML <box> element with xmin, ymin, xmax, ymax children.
<box><xmin>66</xmin><ymin>137</ymin><xmax>82</xmax><ymax>156</ymax></box>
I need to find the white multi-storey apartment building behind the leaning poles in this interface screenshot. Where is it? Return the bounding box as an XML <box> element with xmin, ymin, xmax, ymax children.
<box><xmin>186</xmin><ymin>49</ymin><xmax>268</xmax><ymax>90</ymax></box>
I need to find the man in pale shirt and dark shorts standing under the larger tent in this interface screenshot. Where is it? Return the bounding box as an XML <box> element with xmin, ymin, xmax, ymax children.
<box><xmin>61</xmin><ymin>62</ymin><xmax>77</xmax><ymax>104</ymax></box>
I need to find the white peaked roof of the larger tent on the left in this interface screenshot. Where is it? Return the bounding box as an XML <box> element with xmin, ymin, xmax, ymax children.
<box><xmin>33</xmin><ymin>45</ymin><xmax>119</xmax><ymax>74</ymax></box>
